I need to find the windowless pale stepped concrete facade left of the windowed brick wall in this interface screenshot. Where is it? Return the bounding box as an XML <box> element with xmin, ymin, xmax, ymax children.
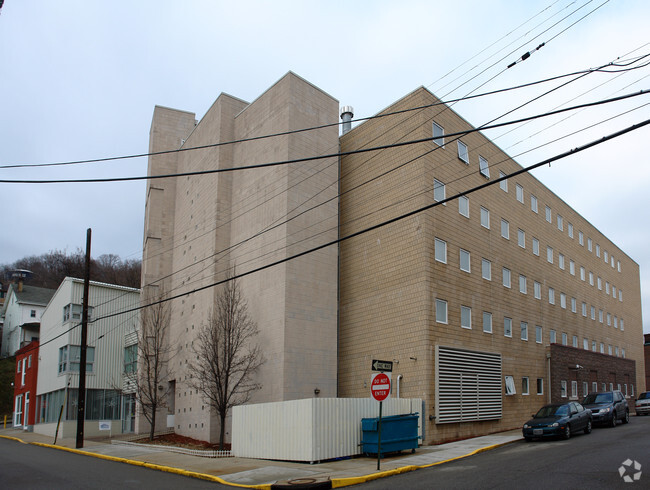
<box><xmin>142</xmin><ymin>73</ymin><xmax>338</xmax><ymax>440</ymax></box>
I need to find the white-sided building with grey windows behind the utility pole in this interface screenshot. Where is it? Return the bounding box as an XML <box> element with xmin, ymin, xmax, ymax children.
<box><xmin>34</xmin><ymin>277</ymin><xmax>140</xmax><ymax>437</ymax></box>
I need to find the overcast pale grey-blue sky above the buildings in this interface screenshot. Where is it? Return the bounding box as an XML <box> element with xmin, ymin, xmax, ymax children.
<box><xmin>0</xmin><ymin>0</ymin><xmax>650</xmax><ymax>332</ymax></box>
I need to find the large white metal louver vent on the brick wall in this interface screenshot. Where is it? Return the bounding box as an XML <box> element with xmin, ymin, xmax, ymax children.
<box><xmin>436</xmin><ymin>346</ymin><xmax>502</xmax><ymax>424</ymax></box>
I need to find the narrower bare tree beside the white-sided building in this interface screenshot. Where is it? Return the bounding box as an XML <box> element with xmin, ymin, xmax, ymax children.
<box><xmin>133</xmin><ymin>286</ymin><xmax>171</xmax><ymax>440</ymax></box>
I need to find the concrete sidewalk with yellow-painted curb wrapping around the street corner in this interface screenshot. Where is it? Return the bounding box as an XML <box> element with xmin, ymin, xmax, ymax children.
<box><xmin>0</xmin><ymin>428</ymin><xmax>522</xmax><ymax>489</ymax></box>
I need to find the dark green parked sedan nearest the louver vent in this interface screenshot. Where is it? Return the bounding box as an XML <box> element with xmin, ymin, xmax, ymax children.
<box><xmin>522</xmin><ymin>402</ymin><xmax>591</xmax><ymax>441</ymax></box>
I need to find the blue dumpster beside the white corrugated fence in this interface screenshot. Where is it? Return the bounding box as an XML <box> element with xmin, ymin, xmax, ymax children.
<box><xmin>361</xmin><ymin>413</ymin><xmax>419</xmax><ymax>457</ymax></box>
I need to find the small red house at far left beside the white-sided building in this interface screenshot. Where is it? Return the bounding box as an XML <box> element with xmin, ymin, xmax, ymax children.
<box><xmin>13</xmin><ymin>340</ymin><xmax>39</xmax><ymax>429</ymax></box>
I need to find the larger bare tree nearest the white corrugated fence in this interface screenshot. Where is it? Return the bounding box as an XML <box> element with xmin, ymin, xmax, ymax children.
<box><xmin>190</xmin><ymin>279</ymin><xmax>264</xmax><ymax>449</ymax></box>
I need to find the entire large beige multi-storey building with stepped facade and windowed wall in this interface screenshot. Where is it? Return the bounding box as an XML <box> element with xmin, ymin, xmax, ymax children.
<box><xmin>143</xmin><ymin>73</ymin><xmax>644</xmax><ymax>443</ymax></box>
